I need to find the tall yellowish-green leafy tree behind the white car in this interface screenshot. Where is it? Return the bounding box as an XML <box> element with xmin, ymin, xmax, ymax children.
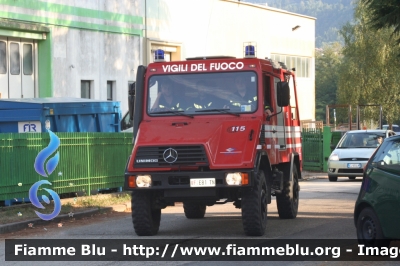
<box><xmin>337</xmin><ymin>1</ymin><xmax>400</xmax><ymax>127</ymax></box>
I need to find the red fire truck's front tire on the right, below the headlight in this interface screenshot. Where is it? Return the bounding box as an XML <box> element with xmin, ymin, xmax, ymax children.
<box><xmin>242</xmin><ymin>171</ymin><xmax>268</xmax><ymax>236</ymax></box>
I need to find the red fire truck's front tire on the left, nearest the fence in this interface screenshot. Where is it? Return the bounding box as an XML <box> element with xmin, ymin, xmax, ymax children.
<box><xmin>132</xmin><ymin>191</ymin><xmax>161</xmax><ymax>236</ymax></box>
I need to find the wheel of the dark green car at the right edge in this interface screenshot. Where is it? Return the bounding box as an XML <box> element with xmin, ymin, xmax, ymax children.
<box><xmin>356</xmin><ymin>207</ymin><xmax>390</xmax><ymax>247</ymax></box>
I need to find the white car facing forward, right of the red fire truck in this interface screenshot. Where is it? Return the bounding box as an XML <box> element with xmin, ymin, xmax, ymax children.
<box><xmin>328</xmin><ymin>130</ymin><xmax>396</xmax><ymax>181</ymax></box>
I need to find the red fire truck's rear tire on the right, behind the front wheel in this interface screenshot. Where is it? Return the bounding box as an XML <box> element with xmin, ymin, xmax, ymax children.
<box><xmin>276</xmin><ymin>166</ymin><xmax>300</xmax><ymax>219</ymax></box>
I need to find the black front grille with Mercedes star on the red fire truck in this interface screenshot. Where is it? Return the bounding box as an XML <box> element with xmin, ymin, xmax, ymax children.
<box><xmin>134</xmin><ymin>146</ymin><xmax>208</xmax><ymax>168</ymax></box>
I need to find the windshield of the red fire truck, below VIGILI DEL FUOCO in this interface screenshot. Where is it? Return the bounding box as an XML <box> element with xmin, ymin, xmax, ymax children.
<box><xmin>147</xmin><ymin>71</ymin><xmax>257</xmax><ymax>117</ymax></box>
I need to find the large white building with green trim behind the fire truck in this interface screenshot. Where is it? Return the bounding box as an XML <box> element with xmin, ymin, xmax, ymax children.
<box><xmin>0</xmin><ymin>0</ymin><xmax>315</xmax><ymax>120</ymax></box>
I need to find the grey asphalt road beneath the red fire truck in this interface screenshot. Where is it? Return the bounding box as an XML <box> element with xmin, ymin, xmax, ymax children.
<box><xmin>0</xmin><ymin>175</ymin><xmax>398</xmax><ymax>265</ymax></box>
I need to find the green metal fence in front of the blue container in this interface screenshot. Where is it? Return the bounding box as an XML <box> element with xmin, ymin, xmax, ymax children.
<box><xmin>0</xmin><ymin>132</ymin><xmax>132</xmax><ymax>201</ymax></box>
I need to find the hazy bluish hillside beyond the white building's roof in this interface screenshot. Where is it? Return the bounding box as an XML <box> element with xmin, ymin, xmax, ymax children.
<box><xmin>242</xmin><ymin>0</ymin><xmax>354</xmax><ymax>48</ymax></box>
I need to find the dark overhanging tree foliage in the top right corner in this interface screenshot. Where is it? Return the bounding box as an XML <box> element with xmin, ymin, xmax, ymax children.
<box><xmin>360</xmin><ymin>0</ymin><xmax>400</xmax><ymax>44</ymax></box>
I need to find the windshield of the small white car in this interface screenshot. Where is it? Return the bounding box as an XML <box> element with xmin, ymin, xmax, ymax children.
<box><xmin>338</xmin><ymin>132</ymin><xmax>385</xmax><ymax>148</ymax></box>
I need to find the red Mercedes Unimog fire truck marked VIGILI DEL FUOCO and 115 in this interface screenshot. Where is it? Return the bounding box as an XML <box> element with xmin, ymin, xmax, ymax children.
<box><xmin>125</xmin><ymin>45</ymin><xmax>302</xmax><ymax>236</ymax></box>
